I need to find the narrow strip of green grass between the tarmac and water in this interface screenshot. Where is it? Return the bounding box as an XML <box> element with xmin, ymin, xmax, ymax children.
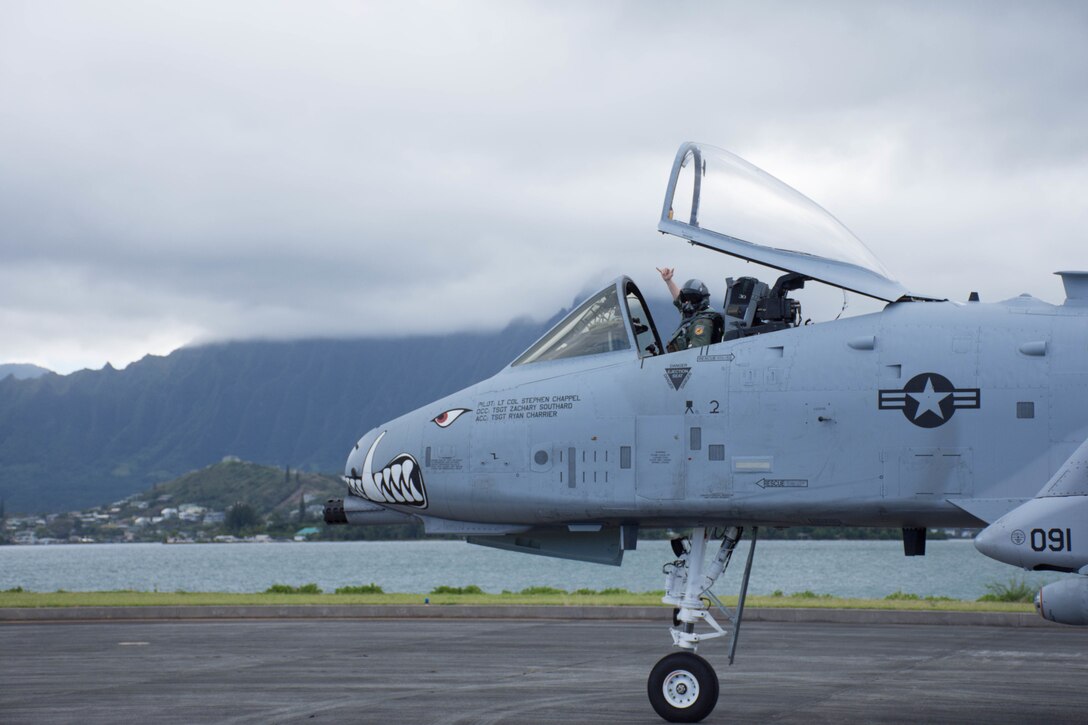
<box><xmin>0</xmin><ymin>585</ymin><xmax>1034</xmax><ymax>613</ymax></box>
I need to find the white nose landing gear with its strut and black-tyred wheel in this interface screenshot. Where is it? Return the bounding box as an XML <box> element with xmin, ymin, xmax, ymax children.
<box><xmin>646</xmin><ymin>526</ymin><xmax>759</xmax><ymax>723</ymax></box>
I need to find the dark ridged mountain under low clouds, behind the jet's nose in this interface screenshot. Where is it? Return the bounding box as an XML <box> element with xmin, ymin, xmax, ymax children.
<box><xmin>0</xmin><ymin>312</ymin><xmax>565</xmax><ymax>512</ymax></box>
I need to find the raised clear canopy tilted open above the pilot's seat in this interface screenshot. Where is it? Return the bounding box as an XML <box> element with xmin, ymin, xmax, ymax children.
<box><xmin>657</xmin><ymin>143</ymin><xmax>911</xmax><ymax>302</ymax></box>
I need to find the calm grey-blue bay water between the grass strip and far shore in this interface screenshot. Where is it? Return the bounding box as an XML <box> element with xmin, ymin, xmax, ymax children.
<box><xmin>0</xmin><ymin>540</ymin><xmax>1060</xmax><ymax>600</ymax></box>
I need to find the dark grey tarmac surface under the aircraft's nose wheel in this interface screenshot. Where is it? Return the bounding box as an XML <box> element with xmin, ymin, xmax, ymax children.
<box><xmin>0</xmin><ymin>619</ymin><xmax>1088</xmax><ymax>725</ymax></box>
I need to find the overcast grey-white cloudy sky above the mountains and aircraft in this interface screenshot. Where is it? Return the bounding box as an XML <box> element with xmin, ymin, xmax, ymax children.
<box><xmin>0</xmin><ymin>0</ymin><xmax>1088</xmax><ymax>372</ymax></box>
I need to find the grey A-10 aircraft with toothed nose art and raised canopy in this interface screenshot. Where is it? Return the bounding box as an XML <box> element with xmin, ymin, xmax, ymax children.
<box><xmin>325</xmin><ymin>144</ymin><xmax>1088</xmax><ymax>722</ymax></box>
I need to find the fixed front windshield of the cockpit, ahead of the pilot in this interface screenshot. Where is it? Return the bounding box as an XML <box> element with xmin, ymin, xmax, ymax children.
<box><xmin>511</xmin><ymin>278</ymin><xmax>660</xmax><ymax>366</ymax></box>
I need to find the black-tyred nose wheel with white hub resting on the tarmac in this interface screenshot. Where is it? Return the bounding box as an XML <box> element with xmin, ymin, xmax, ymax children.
<box><xmin>646</xmin><ymin>652</ymin><xmax>718</xmax><ymax>723</ymax></box>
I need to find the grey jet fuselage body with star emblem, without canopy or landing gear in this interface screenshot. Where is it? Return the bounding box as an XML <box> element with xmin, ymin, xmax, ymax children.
<box><xmin>349</xmin><ymin>279</ymin><xmax>1088</xmax><ymax>531</ymax></box>
